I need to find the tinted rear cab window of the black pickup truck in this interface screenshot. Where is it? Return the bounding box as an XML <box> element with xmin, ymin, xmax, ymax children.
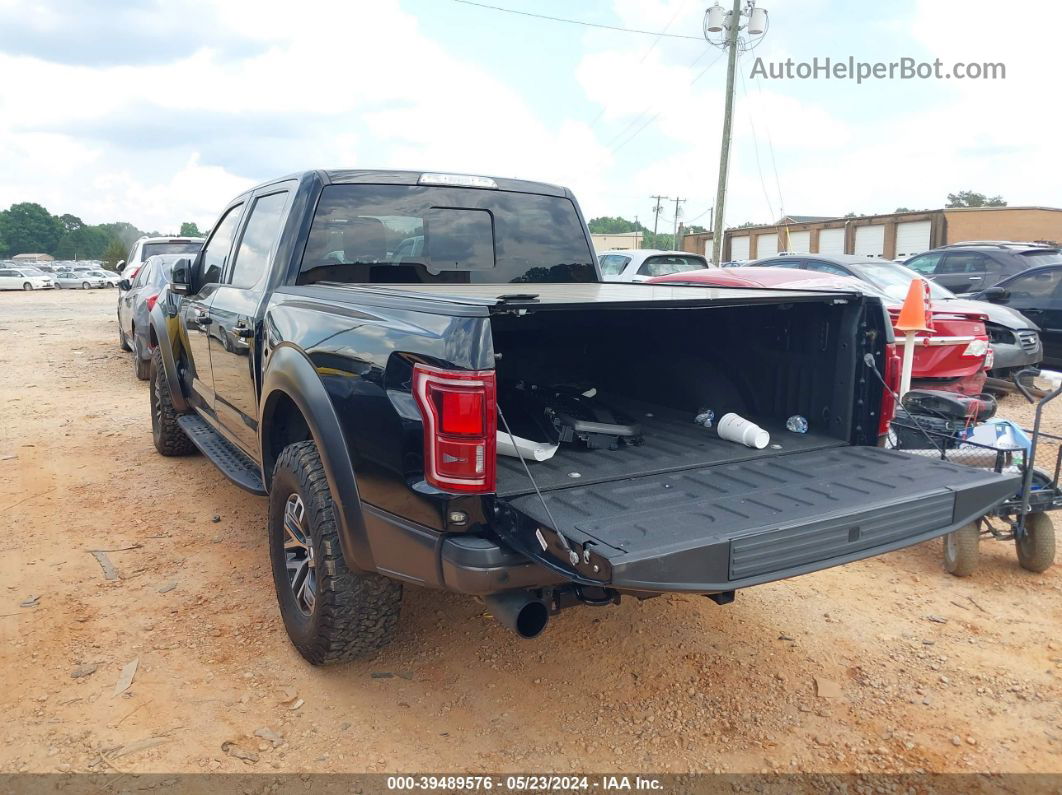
<box><xmin>298</xmin><ymin>185</ymin><xmax>598</xmax><ymax>284</ymax></box>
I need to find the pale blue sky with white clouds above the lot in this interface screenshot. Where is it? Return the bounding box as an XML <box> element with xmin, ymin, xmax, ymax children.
<box><xmin>0</xmin><ymin>0</ymin><xmax>1062</xmax><ymax>234</ymax></box>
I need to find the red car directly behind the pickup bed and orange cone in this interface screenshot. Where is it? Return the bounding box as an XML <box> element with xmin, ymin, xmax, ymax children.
<box><xmin>648</xmin><ymin>267</ymin><xmax>992</xmax><ymax>396</ymax></box>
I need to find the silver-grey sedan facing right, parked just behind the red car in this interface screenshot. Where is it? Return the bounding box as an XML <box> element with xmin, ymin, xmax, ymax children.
<box><xmin>750</xmin><ymin>254</ymin><xmax>1044</xmax><ymax>381</ymax></box>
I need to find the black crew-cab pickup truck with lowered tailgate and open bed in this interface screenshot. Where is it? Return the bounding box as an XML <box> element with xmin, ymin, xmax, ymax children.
<box><xmin>151</xmin><ymin>171</ymin><xmax>1017</xmax><ymax>663</ymax></box>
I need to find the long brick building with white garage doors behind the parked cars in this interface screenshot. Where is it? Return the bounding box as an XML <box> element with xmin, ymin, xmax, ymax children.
<box><xmin>682</xmin><ymin>207</ymin><xmax>1062</xmax><ymax>261</ymax></box>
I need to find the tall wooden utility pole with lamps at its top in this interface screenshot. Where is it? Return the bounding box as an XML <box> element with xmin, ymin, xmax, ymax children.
<box><xmin>704</xmin><ymin>0</ymin><xmax>767</xmax><ymax>265</ymax></box>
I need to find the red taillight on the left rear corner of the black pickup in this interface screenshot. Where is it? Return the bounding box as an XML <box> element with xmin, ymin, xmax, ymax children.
<box><xmin>413</xmin><ymin>364</ymin><xmax>498</xmax><ymax>494</ymax></box>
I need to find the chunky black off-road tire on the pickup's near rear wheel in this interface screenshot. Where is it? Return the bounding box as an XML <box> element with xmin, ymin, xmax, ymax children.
<box><xmin>269</xmin><ymin>442</ymin><xmax>401</xmax><ymax>666</ymax></box>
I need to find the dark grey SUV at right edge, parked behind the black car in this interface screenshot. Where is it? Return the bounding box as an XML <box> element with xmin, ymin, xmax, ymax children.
<box><xmin>904</xmin><ymin>240</ymin><xmax>1062</xmax><ymax>294</ymax></box>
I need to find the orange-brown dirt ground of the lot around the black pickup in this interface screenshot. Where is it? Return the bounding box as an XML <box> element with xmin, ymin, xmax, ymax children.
<box><xmin>0</xmin><ymin>290</ymin><xmax>1062</xmax><ymax>773</ymax></box>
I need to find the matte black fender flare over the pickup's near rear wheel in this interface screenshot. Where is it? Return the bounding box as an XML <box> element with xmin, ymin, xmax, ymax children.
<box><xmin>258</xmin><ymin>344</ymin><xmax>376</xmax><ymax>571</ymax></box>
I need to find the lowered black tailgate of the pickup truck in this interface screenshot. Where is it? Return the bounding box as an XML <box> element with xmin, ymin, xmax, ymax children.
<box><xmin>508</xmin><ymin>447</ymin><xmax>1020</xmax><ymax>593</ymax></box>
